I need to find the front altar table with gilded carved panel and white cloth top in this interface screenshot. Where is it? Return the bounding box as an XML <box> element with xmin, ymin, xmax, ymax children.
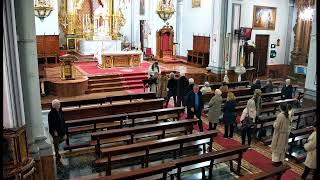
<box><xmin>98</xmin><ymin>51</ymin><xmax>143</xmax><ymax>68</ymax></box>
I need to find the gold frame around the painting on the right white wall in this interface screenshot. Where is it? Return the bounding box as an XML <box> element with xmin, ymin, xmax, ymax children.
<box><xmin>252</xmin><ymin>5</ymin><xmax>277</xmax><ymax>30</ymax></box>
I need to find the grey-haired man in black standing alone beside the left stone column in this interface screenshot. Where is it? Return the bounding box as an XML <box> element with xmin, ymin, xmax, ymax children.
<box><xmin>48</xmin><ymin>99</ymin><xmax>66</xmax><ymax>159</ymax></box>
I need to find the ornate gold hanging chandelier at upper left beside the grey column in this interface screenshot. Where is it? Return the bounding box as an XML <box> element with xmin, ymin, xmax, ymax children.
<box><xmin>34</xmin><ymin>0</ymin><xmax>53</xmax><ymax>21</ymax></box>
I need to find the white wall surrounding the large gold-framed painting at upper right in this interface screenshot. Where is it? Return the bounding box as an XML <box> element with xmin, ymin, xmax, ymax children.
<box><xmin>240</xmin><ymin>0</ymin><xmax>289</xmax><ymax>65</ymax></box>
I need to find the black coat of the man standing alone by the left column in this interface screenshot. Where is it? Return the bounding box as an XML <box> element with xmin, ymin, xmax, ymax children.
<box><xmin>48</xmin><ymin>108</ymin><xmax>66</xmax><ymax>137</ymax></box>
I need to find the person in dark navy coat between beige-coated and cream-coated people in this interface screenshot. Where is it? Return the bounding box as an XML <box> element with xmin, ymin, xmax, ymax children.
<box><xmin>223</xmin><ymin>92</ymin><xmax>237</xmax><ymax>138</ymax></box>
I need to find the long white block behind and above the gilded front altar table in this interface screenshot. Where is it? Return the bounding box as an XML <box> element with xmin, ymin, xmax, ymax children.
<box><xmin>79</xmin><ymin>40</ymin><xmax>121</xmax><ymax>55</ymax></box>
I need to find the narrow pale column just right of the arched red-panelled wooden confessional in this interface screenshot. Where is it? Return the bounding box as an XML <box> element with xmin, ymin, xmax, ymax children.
<box><xmin>176</xmin><ymin>0</ymin><xmax>183</xmax><ymax>56</ymax></box>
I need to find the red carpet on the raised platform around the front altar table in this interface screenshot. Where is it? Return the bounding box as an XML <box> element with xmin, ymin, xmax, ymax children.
<box><xmin>75</xmin><ymin>61</ymin><xmax>166</xmax><ymax>76</ymax></box>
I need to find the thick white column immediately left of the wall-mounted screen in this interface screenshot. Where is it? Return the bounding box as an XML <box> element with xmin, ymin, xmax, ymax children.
<box><xmin>209</xmin><ymin>0</ymin><xmax>228</xmax><ymax>74</ymax></box>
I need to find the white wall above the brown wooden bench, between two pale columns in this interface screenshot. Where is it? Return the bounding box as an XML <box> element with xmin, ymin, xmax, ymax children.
<box><xmin>179</xmin><ymin>0</ymin><xmax>213</xmax><ymax>56</ymax></box>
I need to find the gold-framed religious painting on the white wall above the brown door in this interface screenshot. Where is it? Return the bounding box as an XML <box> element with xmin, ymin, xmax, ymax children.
<box><xmin>252</xmin><ymin>6</ymin><xmax>277</xmax><ymax>30</ymax></box>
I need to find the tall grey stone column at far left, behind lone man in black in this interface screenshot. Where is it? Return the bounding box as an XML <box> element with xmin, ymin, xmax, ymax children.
<box><xmin>14</xmin><ymin>0</ymin><xmax>51</xmax><ymax>153</ymax></box>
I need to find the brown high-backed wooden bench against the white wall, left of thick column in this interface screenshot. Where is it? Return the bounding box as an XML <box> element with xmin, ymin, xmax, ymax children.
<box><xmin>188</xmin><ymin>35</ymin><xmax>210</xmax><ymax>67</ymax></box>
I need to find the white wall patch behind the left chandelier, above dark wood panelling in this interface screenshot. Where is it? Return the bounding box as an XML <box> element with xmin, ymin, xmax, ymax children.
<box><xmin>34</xmin><ymin>0</ymin><xmax>59</xmax><ymax>35</ymax></box>
